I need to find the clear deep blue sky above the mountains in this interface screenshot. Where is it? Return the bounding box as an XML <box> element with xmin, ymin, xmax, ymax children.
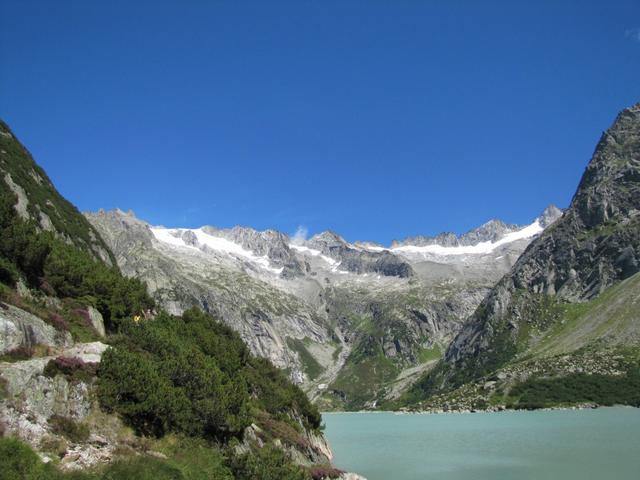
<box><xmin>0</xmin><ymin>0</ymin><xmax>640</xmax><ymax>243</ymax></box>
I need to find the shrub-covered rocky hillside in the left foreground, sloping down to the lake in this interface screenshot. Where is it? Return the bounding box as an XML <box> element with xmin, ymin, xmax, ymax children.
<box><xmin>0</xmin><ymin>117</ymin><xmax>358</xmax><ymax>480</ymax></box>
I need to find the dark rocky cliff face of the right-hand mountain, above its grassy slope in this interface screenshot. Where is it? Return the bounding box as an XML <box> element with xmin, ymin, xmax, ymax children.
<box><xmin>429</xmin><ymin>105</ymin><xmax>640</xmax><ymax>391</ymax></box>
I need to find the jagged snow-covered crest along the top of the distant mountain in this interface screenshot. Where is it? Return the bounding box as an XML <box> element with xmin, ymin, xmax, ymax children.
<box><xmin>142</xmin><ymin>206</ymin><xmax>562</xmax><ymax>277</ymax></box>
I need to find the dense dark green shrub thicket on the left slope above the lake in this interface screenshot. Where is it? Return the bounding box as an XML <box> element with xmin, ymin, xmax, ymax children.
<box><xmin>98</xmin><ymin>309</ymin><xmax>321</xmax><ymax>440</ymax></box>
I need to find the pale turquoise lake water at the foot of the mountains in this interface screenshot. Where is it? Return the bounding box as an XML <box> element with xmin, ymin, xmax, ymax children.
<box><xmin>323</xmin><ymin>408</ymin><xmax>640</xmax><ymax>480</ymax></box>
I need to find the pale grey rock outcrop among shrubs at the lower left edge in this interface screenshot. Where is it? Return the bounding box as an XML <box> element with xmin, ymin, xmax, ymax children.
<box><xmin>0</xmin><ymin>342</ymin><xmax>124</xmax><ymax>470</ymax></box>
